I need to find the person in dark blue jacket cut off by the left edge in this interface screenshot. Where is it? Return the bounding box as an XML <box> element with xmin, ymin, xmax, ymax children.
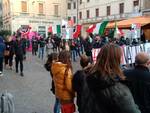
<box><xmin>0</xmin><ymin>36</ymin><xmax>5</xmax><ymax>76</ymax></box>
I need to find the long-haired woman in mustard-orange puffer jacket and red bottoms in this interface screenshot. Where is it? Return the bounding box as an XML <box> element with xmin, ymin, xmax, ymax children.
<box><xmin>51</xmin><ymin>50</ymin><xmax>75</xmax><ymax>113</ymax></box>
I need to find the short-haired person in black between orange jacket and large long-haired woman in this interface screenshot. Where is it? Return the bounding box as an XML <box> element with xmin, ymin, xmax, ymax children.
<box><xmin>72</xmin><ymin>55</ymin><xmax>92</xmax><ymax>113</ymax></box>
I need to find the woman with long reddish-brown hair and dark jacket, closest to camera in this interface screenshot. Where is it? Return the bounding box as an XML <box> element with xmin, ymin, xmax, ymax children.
<box><xmin>82</xmin><ymin>44</ymin><xmax>141</xmax><ymax>113</ymax></box>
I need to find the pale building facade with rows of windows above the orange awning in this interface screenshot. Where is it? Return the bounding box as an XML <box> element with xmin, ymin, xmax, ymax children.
<box><xmin>68</xmin><ymin>0</ymin><xmax>150</xmax><ymax>36</ymax></box>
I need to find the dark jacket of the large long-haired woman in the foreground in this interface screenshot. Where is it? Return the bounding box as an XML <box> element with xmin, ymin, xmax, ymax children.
<box><xmin>87</xmin><ymin>72</ymin><xmax>140</xmax><ymax>113</ymax></box>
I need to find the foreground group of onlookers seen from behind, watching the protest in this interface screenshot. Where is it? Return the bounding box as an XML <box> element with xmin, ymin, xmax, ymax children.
<box><xmin>45</xmin><ymin>39</ymin><xmax>150</xmax><ymax>113</ymax></box>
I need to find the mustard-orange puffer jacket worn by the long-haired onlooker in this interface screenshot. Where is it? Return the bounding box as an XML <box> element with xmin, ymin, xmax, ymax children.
<box><xmin>51</xmin><ymin>62</ymin><xmax>74</xmax><ymax>102</ymax></box>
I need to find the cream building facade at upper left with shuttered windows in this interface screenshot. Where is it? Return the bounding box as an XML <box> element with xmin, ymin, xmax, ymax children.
<box><xmin>2</xmin><ymin>0</ymin><xmax>67</xmax><ymax>36</ymax></box>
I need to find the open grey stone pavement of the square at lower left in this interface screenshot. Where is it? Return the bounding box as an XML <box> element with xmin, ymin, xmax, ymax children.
<box><xmin>0</xmin><ymin>54</ymin><xmax>79</xmax><ymax>113</ymax></box>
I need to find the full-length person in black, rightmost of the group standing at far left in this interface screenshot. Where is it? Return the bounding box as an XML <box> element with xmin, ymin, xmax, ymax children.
<box><xmin>14</xmin><ymin>36</ymin><xmax>26</xmax><ymax>76</ymax></box>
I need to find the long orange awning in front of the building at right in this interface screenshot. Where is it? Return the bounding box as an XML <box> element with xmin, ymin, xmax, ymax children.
<box><xmin>107</xmin><ymin>16</ymin><xmax>150</xmax><ymax>29</ymax></box>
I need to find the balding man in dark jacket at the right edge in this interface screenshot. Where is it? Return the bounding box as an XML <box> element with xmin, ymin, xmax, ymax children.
<box><xmin>124</xmin><ymin>53</ymin><xmax>150</xmax><ymax>113</ymax></box>
